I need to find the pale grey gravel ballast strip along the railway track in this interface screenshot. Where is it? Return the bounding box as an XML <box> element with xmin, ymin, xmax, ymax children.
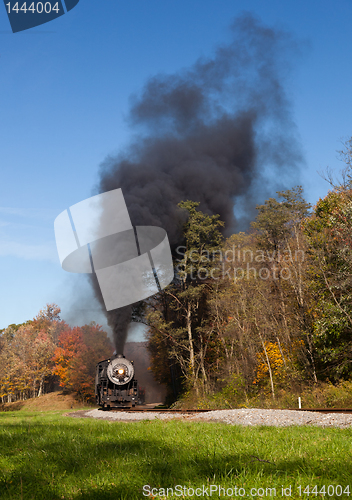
<box><xmin>67</xmin><ymin>408</ymin><xmax>352</xmax><ymax>428</ymax></box>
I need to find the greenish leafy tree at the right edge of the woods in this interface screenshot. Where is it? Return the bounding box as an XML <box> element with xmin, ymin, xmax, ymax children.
<box><xmin>305</xmin><ymin>186</ymin><xmax>352</xmax><ymax>381</ymax></box>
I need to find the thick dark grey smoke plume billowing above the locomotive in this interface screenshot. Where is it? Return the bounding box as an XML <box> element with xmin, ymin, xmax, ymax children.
<box><xmin>92</xmin><ymin>14</ymin><xmax>300</xmax><ymax>354</ymax></box>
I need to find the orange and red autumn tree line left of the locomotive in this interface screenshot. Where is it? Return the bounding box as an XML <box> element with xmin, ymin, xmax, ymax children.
<box><xmin>0</xmin><ymin>304</ymin><xmax>113</xmax><ymax>403</ymax></box>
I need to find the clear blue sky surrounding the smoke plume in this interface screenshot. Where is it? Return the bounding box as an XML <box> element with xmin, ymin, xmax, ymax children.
<box><xmin>0</xmin><ymin>0</ymin><xmax>352</xmax><ymax>336</ymax></box>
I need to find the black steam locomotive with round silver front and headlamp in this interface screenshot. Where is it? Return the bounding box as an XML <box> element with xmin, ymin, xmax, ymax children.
<box><xmin>95</xmin><ymin>354</ymin><xmax>144</xmax><ymax>410</ymax></box>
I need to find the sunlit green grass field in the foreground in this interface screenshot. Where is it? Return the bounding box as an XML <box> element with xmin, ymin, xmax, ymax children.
<box><xmin>0</xmin><ymin>412</ymin><xmax>352</xmax><ymax>500</ymax></box>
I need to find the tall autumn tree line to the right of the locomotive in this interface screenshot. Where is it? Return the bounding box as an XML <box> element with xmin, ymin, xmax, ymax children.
<box><xmin>145</xmin><ymin>140</ymin><xmax>352</xmax><ymax>399</ymax></box>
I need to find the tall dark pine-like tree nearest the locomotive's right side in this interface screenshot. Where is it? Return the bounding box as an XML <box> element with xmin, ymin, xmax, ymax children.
<box><xmin>147</xmin><ymin>201</ymin><xmax>223</xmax><ymax>392</ymax></box>
